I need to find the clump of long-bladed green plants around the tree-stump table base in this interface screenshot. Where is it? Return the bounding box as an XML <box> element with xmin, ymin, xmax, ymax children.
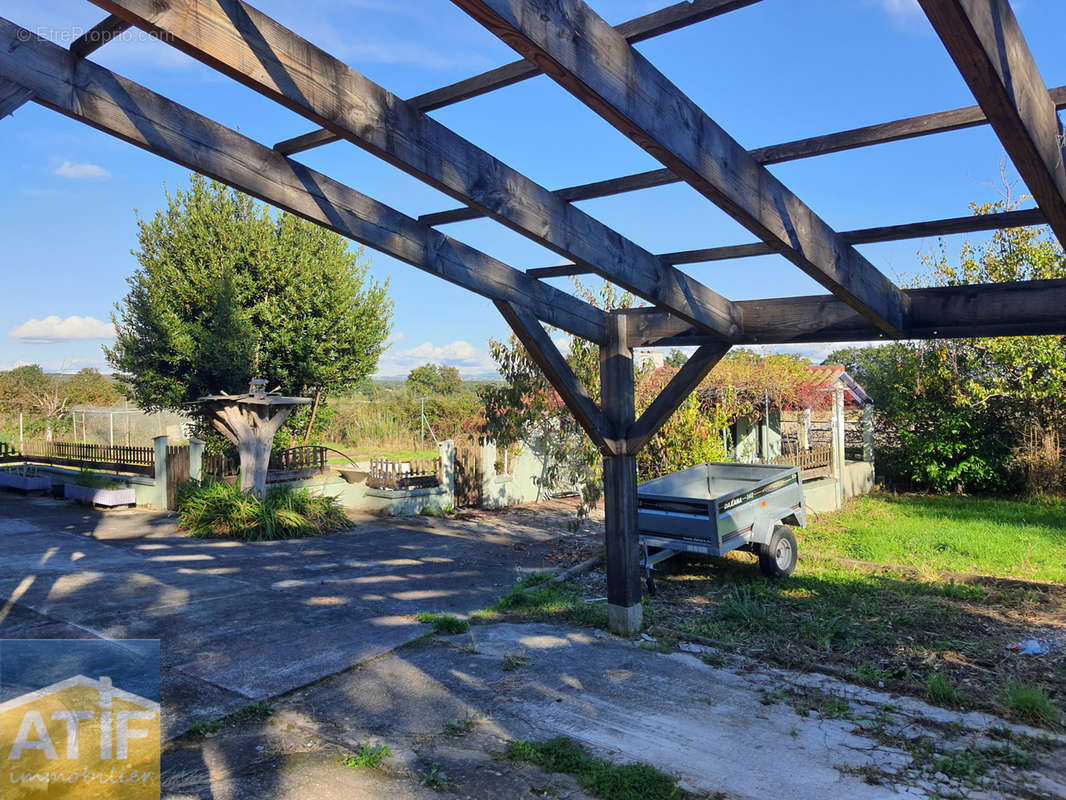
<box><xmin>178</xmin><ymin>481</ymin><xmax>351</xmax><ymax>542</ymax></box>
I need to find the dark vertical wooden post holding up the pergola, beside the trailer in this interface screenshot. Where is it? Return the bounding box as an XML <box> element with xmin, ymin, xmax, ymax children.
<box><xmin>600</xmin><ymin>314</ymin><xmax>644</xmax><ymax>636</ymax></box>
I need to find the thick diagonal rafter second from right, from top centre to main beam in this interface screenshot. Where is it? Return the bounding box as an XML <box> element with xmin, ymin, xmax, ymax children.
<box><xmin>453</xmin><ymin>0</ymin><xmax>906</xmax><ymax>336</ymax></box>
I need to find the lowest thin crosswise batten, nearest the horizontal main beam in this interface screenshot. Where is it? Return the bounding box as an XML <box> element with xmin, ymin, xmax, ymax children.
<box><xmin>528</xmin><ymin>208</ymin><xmax>1046</xmax><ymax>278</ymax></box>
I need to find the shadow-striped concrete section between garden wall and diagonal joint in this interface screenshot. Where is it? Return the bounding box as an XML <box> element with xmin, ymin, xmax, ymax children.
<box><xmin>0</xmin><ymin>501</ymin><xmax>566</xmax><ymax>737</ymax></box>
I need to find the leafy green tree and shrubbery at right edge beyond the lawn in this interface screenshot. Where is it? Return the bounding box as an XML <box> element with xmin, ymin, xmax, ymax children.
<box><xmin>829</xmin><ymin>198</ymin><xmax>1066</xmax><ymax>491</ymax></box>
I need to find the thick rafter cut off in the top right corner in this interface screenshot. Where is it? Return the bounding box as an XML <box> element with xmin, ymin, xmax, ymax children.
<box><xmin>919</xmin><ymin>0</ymin><xmax>1066</xmax><ymax>244</ymax></box>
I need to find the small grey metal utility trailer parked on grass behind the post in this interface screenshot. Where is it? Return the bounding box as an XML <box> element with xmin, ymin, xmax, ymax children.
<box><xmin>636</xmin><ymin>463</ymin><xmax>807</xmax><ymax>593</ymax></box>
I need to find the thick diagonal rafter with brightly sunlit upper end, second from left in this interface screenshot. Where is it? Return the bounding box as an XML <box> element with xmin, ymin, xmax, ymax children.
<box><xmin>93</xmin><ymin>0</ymin><xmax>738</xmax><ymax>340</ymax></box>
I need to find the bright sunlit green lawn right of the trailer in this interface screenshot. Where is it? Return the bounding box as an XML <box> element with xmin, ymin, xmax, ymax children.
<box><xmin>801</xmin><ymin>494</ymin><xmax>1066</xmax><ymax>582</ymax></box>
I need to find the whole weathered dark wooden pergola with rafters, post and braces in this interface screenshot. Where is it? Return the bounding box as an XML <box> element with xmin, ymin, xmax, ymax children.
<box><xmin>0</xmin><ymin>0</ymin><xmax>1066</xmax><ymax>633</ymax></box>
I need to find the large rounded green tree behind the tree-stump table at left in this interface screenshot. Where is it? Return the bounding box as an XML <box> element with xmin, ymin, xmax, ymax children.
<box><xmin>104</xmin><ymin>174</ymin><xmax>392</xmax><ymax>445</ymax></box>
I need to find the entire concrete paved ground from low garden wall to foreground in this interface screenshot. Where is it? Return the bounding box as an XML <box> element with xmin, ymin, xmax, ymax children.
<box><xmin>0</xmin><ymin>494</ymin><xmax>1066</xmax><ymax>800</ymax></box>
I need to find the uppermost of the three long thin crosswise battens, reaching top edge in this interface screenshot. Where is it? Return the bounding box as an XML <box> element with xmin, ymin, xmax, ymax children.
<box><xmin>274</xmin><ymin>0</ymin><xmax>759</xmax><ymax>156</ymax></box>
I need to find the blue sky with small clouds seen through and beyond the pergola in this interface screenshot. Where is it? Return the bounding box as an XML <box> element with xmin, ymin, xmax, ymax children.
<box><xmin>0</xmin><ymin>0</ymin><xmax>1066</xmax><ymax>375</ymax></box>
